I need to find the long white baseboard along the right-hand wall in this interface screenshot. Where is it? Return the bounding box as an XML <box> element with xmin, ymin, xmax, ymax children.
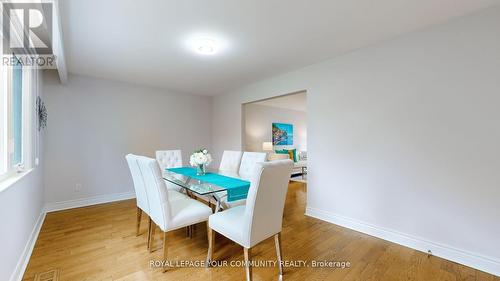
<box><xmin>306</xmin><ymin>207</ymin><xmax>500</xmax><ymax>276</ymax></box>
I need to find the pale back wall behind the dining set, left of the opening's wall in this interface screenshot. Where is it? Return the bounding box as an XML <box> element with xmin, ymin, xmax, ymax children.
<box><xmin>44</xmin><ymin>75</ymin><xmax>211</xmax><ymax>206</ymax></box>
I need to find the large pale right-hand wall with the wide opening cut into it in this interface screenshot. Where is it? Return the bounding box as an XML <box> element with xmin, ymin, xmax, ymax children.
<box><xmin>212</xmin><ymin>8</ymin><xmax>500</xmax><ymax>275</ymax></box>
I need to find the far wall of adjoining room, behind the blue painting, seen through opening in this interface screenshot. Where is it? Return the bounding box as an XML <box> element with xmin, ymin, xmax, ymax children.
<box><xmin>244</xmin><ymin>104</ymin><xmax>307</xmax><ymax>151</ymax></box>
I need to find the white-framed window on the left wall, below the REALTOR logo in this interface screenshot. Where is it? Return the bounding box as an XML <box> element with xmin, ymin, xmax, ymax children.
<box><xmin>0</xmin><ymin>56</ymin><xmax>36</xmax><ymax>180</ymax></box>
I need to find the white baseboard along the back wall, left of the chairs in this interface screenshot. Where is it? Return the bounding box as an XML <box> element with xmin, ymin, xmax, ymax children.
<box><xmin>45</xmin><ymin>191</ymin><xmax>135</xmax><ymax>213</ymax></box>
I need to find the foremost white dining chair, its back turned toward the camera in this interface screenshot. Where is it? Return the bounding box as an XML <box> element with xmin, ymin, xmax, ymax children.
<box><xmin>207</xmin><ymin>159</ymin><xmax>293</xmax><ymax>280</ymax></box>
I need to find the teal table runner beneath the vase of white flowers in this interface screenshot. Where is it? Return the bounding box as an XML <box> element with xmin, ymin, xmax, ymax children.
<box><xmin>167</xmin><ymin>167</ymin><xmax>250</xmax><ymax>202</ymax></box>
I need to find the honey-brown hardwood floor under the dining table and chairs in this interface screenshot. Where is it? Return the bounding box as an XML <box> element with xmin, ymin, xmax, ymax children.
<box><xmin>23</xmin><ymin>182</ymin><xmax>500</xmax><ymax>281</ymax></box>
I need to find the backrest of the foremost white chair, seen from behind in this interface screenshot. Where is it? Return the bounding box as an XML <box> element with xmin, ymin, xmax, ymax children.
<box><xmin>243</xmin><ymin>159</ymin><xmax>293</xmax><ymax>247</ymax></box>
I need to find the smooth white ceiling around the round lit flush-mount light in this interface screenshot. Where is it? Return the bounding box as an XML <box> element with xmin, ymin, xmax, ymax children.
<box><xmin>60</xmin><ymin>0</ymin><xmax>498</xmax><ymax>95</ymax></box>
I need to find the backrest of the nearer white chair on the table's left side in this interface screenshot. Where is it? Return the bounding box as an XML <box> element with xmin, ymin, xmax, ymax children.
<box><xmin>138</xmin><ymin>157</ymin><xmax>170</xmax><ymax>230</ymax></box>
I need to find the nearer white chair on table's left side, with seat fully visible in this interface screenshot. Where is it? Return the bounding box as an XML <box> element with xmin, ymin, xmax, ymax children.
<box><xmin>138</xmin><ymin>157</ymin><xmax>212</xmax><ymax>272</ymax></box>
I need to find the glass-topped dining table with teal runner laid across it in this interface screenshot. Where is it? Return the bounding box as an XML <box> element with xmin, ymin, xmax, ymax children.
<box><xmin>162</xmin><ymin>167</ymin><xmax>250</xmax><ymax>213</ymax></box>
